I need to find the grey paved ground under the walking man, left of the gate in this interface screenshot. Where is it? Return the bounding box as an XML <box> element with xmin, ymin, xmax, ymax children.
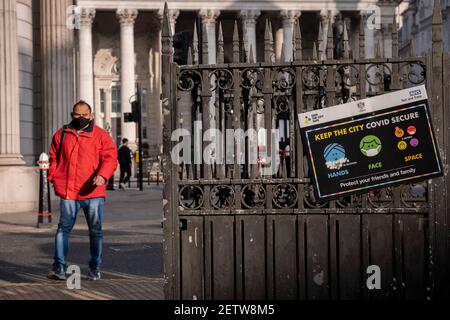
<box><xmin>0</xmin><ymin>184</ymin><xmax>164</xmax><ymax>300</ymax></box>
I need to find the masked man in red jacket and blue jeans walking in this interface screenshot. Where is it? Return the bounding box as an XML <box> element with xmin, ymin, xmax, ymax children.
<box><xmin>48</xmin><ymin>101</ymin><xmax>117</xmax><ymax>280</ymax></box>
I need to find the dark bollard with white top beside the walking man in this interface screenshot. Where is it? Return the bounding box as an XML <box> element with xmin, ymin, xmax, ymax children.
<box><xmin>36</xmin><ymin>152</ymin><xmax>52</xmax><ymax>228</ymax></box>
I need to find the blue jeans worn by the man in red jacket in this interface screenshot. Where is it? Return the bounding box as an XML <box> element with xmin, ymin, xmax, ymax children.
<box><xmin>53</xmin><ymin>198</ymin><xmax>105</xmax><ymax>270</ymax></box>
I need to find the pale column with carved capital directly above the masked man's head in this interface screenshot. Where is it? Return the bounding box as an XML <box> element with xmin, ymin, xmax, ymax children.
<box><xmin>79</xmin><ymin>8</ymin><xmax>97</xmax><ymax>107</ymax></box>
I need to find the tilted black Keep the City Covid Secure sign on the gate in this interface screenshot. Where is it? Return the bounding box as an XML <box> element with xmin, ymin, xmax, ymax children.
<box><xmin>298</xmin><ymin>85</ymin><xmax>443</xmax><ymax>200</ymax></box>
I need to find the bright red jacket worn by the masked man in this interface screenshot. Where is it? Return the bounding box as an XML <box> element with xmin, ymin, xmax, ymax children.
<box><xmin>48</xmin><ymin>122</ymin><xmax>117</xmax><ymax>200</ymax></box>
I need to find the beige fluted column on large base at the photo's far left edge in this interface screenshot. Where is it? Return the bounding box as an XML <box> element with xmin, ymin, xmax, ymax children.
<box><xmin>0</xmin><ymin>0</ymin><xmax>25</xmax><ymax>166</ymax></box>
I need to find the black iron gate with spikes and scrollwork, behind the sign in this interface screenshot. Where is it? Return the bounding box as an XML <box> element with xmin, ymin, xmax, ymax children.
<box><xmin>162</xmin><ymin>1</ymin><xmax>450</xmax><ymax>299</ymax></box>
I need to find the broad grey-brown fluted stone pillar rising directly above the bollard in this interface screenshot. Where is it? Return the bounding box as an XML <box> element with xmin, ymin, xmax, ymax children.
<box><xmin>40</xmin><ymin>0</ymin><xmax>75</xmax><ymax>152</ymax></box>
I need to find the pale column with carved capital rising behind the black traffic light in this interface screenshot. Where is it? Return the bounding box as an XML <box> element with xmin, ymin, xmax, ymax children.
<box><xmin>117</xmin><ymin>9</ymin><xmax>138</xmax><ymax>150</ymax></box>
